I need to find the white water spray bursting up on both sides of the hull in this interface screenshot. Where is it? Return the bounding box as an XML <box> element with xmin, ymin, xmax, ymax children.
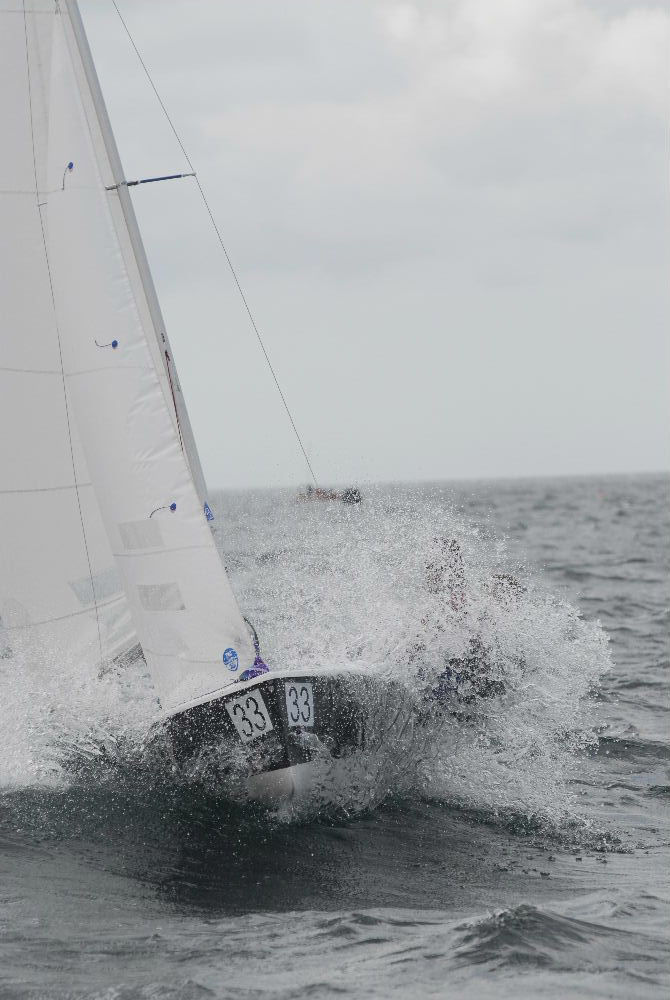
<box><xmin>0</xmin><ymin>490</ymin><xmax>609</xmax><ymax>822</ymax></box>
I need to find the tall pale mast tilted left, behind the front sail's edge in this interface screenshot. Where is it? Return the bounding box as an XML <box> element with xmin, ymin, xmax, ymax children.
<box><xmin>65</xmin><ymin>0</ymin><xmax>207</xmax><ymax>505</ymax></box>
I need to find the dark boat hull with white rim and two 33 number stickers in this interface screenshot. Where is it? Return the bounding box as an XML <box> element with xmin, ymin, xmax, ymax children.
<box><xmin>165</xmin><ymin>668</ymin><xmax>415</xmax><ymax>805</ymax></box>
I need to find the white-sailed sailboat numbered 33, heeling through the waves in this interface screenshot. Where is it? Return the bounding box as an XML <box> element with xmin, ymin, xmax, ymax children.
<box><xmin>0</xmin><ymin>0</ymin><xmax>412</xmax><ymax>802</ymax></box>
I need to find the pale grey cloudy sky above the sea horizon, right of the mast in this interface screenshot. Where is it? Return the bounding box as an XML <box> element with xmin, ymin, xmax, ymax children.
<box><xmin>80</xmin><ymin>0</ymin><xmax>670</xmax><ymax>486</ymax></box>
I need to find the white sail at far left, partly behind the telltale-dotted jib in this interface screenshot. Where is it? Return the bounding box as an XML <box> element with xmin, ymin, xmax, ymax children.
<box><xmin>0</xmin><ymin>0</ymin><xmax>137</xmax><ymax>671</ymax></box>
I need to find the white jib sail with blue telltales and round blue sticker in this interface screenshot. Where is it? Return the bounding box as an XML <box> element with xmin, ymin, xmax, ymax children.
<box><xmin>47</xmin><ymin>0</ymin><xmax>254</xmax><ymax>712</ymax></box>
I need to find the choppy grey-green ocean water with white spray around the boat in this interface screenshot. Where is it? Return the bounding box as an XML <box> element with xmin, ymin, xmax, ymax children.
<box><xmin>0</xmin><ymin>476</ymin><xmax>670</xmax><ymax>1000</ymax></box>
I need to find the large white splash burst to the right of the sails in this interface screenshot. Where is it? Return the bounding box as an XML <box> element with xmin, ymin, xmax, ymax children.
<box><xmin>231</xmin><ymin>490</ymin><xmax>611</xmax><ymax>821</ymax></box>
